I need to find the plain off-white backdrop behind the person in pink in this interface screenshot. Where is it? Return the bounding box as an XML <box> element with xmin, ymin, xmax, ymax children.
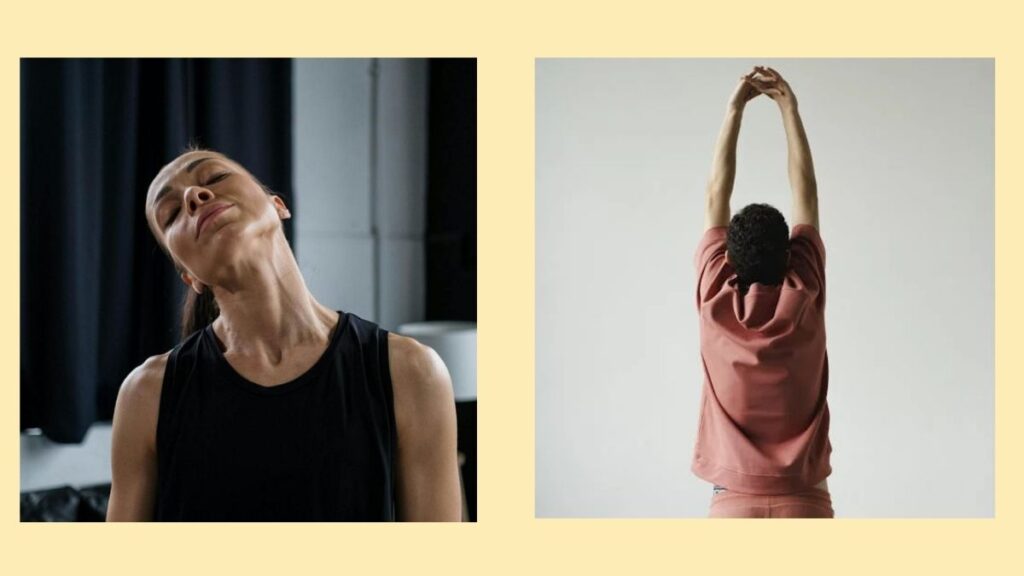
<box><xmin>536</xmin><ymin>58</ymin><xmax>994</xmax><ymax>518</ymax></box>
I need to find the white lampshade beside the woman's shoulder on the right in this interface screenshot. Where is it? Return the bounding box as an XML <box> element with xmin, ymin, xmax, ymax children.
<box><xmin>396</xmin><ymin>322</ymin><xmax>476</xmax><ymax>402</ymax></box>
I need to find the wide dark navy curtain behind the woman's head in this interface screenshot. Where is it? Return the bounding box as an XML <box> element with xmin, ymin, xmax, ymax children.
<box><xmin>20</xmin><ymin>58</ymin><xmax>295</xmax><ymax>443</ymax></box>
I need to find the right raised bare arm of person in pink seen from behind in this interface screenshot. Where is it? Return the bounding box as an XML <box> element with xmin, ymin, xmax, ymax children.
<box><xmin>751</xmin><ymin>67</ymin><xmax>820</xmax><ymax>230</ymax></box>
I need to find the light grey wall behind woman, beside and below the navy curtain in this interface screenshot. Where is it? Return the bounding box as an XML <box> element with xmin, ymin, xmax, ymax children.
<box><xmin>20</xmin><ymin>58</ymin><xmax>427</xmax><ymax>490</ymax></box>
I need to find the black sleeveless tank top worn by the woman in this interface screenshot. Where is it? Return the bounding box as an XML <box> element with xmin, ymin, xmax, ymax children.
<box><xmin>154</xmin><ymin>313</ymin><xmax>396</xmax><ymax>522</ymax></box>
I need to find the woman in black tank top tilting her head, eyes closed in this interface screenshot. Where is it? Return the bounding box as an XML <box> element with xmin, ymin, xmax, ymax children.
<box><xmin>108</xmin><ymin>150</ymin><xmax>461</xmax><ymax>521</ymax></box>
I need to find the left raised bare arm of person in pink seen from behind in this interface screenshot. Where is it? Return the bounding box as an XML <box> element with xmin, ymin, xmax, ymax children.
<box><xmin>705</xmin><ymin>72</ymin><xmax>760</xmax><ymax>230</ymax></box>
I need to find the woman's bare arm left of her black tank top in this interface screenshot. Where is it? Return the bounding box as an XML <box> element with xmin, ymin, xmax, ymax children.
<box><xmin>106</xmin><ymin>354</ymin><xmax>167</xmax><ymax>522</ymax></box>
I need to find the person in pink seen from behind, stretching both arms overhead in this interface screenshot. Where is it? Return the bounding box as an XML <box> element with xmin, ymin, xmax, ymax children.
<box><xmin>691</xmin><ymin>67</ymin><xmax>834</xmax><ymax>518</ymax></box>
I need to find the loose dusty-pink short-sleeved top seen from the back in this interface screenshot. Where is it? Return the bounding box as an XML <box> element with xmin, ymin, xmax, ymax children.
<box><xmin>692</xmin><ymin>224</ymin><xmax>831</xmax><ymax>494</ymax></box>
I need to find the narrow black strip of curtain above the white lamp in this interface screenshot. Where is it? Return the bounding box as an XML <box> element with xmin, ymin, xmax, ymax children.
<box><xmin>426</xmin><ymin>58</ymin><xmax>476</xmax><ymax>321</ymax></box>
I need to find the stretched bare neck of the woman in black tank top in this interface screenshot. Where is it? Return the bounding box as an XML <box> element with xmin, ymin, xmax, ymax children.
<box><xmin>205</xmin><ymin>235</ymin><xmax>337</xmax><ymax>363</ymax></box>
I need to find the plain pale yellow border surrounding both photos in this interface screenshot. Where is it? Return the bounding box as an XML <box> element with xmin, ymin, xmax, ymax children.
<box><xmin>0</xmin><ymin>0</ymin><xmax>1024</xmax><ymax>574</ymax></box>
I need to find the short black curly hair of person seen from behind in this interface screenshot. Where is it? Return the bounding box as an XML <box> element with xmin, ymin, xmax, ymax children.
<box><xmin>726</xmin><ymin>204</ymin><xmax>790</xmax><ymax>290</ymax></box>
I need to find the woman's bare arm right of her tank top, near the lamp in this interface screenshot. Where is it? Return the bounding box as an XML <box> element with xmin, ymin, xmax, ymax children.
<box><xmin>388</xmin><ymin>333</ymin><xmax>462</xmax><ymax>522</ymax></box>
